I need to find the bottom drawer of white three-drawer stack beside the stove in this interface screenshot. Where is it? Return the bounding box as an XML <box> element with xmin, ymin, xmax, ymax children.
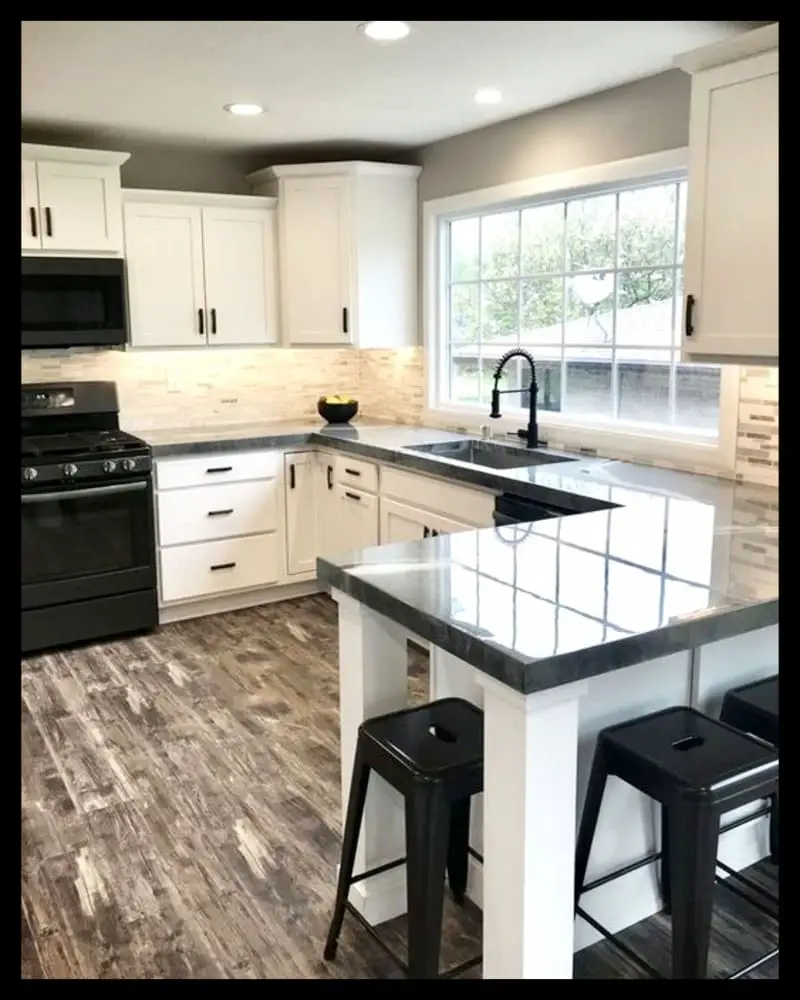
<box><xmin>159</xmin><ymin>532</ymin><xmax>281</xmax><ymax>604</ymax></box>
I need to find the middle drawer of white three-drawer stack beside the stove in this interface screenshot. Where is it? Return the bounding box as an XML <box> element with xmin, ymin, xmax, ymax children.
<box><xmin>158</xmin><ymin>479</ymin><xmax>278</xmax><ymax>545</ymax></box>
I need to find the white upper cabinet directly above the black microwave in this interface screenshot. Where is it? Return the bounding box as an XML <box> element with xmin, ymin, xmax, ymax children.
<box><xmin>22</xmin><ymin>143</ymin><xmax>130</xmax><ymax>256</ymax></box>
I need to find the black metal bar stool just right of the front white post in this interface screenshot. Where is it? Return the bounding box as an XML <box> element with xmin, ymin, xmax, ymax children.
<box><xmin>575</xmin><ymin>707</ymin><xmax>778</xmax><ymax>979</ymax></box>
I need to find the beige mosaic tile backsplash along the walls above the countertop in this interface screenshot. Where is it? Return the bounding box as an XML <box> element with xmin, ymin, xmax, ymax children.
<box><xmin>22</xmin><ymin>347</ymin><xmax>778</xmax><ymax>486</ymax></box>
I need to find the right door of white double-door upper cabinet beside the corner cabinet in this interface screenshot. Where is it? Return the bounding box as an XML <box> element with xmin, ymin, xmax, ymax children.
<box><xmin>202</xmin><ymin>208</ymin><xmax>277</xmax><ymax>345</ymax></box>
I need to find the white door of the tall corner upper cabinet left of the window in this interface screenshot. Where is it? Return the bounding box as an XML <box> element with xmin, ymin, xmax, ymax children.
<box><xmin>279</xmin><ymin>177</ymin><xmax>355</xmax><ymax>344</ymax></box>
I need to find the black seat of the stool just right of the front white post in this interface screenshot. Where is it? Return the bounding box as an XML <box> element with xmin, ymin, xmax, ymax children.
<box><xmin>603</xmin><ymin>707</ymin><xmax>778</xmax><ymax>797</ymax></box>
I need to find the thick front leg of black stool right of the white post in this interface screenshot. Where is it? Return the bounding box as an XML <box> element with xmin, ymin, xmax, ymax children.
<box><xmin>667</xmin><ymin>802</ymin><xmax>719</xmax><ymax>979</ymax></box>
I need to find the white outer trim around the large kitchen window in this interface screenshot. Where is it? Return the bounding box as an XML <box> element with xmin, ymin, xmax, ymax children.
<box><xmin>422</xmin><ymin>148</ymin><xmax>740</xmax><ymax>475</ymax></box>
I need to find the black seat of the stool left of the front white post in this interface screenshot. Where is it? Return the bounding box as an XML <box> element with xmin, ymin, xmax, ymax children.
<box><xmin>361</xmin><ymin>698</ymin><xmax>483</xmax><ymax>780</ymax></box>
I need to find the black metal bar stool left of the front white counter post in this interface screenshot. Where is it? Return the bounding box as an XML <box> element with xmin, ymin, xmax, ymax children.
<box><xmin>324</xmin><ymin>698</ymin><xmax>483</xmax><ymax>979</ymax></box>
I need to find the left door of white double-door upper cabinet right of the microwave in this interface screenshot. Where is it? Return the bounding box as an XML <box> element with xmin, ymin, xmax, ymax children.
<box><xmin>125</xmin><ymin>202</ymin><xmax>208</xmax><ymax>347</ymax></box>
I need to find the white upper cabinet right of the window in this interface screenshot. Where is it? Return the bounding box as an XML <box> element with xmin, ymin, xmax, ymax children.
<box><xmin>678</xmin><ymin>25</ymin><xmax>778</xmax><ymax>364</ymax></box>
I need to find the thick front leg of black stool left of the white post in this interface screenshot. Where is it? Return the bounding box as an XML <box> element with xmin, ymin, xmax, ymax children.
<box><xmin>406</xmin><ymin>782</ymin><xmax>450</xmax><ymax>979</ymax></box>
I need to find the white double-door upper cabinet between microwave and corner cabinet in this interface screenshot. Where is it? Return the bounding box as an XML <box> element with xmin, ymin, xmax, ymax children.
<box><xmin>124</xmin><ymin>190</ymin><xmax>278</xmax><ymax>347</ymax></box>
